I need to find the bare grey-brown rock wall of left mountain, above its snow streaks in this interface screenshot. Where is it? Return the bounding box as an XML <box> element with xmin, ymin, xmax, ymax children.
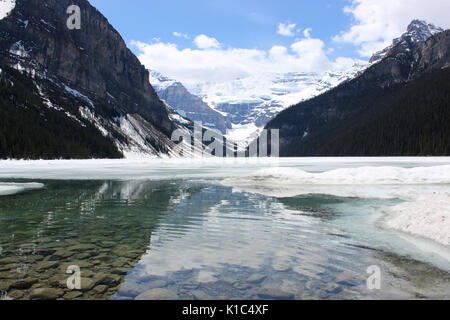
<box><xmin>1</xmin><ymin>0</ymin><xmax>172</xmax><ymax>133</ymax></box>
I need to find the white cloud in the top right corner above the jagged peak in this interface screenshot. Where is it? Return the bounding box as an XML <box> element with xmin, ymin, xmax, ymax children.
<box><xmin>334</xmin><ymin>0</ymin><xmax>450</xmax><ymax>57</ymax></box>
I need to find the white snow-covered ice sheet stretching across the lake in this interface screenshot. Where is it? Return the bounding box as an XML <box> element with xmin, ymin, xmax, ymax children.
<box><xmin>0</xmin><ymin>158</ymin><xmax>450</xmax><ymax>246</ymax></box>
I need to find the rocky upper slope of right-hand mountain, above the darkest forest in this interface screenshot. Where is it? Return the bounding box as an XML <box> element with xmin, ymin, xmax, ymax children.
<box><xmin>267</xmin><ymin>21</ymin><xmax>450</xmax><ymax>155</ymax></box>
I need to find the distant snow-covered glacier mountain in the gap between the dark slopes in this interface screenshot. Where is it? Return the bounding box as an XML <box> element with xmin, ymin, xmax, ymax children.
<box><xmin>192</xmin><ymin>62</ymin><xmax>366</xmax><ymax>140</ymax></box>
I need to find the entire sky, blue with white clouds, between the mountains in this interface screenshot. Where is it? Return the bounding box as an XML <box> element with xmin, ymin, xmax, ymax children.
<box><xmin>90</xmin><ymin>0</ymin><xmax>450</xmax><ymax>88</ymax></box>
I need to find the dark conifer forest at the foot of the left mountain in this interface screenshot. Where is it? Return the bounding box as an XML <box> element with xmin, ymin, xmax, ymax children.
<box><xmin>0</xmin><ymin>66</ymin><xmax>123</xmax><ymax>159</ymax></box>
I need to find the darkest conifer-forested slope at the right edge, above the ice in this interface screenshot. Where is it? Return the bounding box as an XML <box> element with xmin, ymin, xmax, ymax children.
<box><xmin>298</xmin><ymin>68</ymin><xmax>450</xmax><ymax>156</ymax></box>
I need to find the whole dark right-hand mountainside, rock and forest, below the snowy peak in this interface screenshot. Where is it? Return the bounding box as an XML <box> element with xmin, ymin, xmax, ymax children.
<box><xmin>267</xmin><ymin>22</ymin><xmax>450</xmax><ymax>156</ymax></box>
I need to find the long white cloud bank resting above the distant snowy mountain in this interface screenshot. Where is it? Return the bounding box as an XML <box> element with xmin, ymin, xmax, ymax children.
<box><xmin>131</xmin><ymin>37</ymin><xmax>362</xmax><ymax>88</ymax></box>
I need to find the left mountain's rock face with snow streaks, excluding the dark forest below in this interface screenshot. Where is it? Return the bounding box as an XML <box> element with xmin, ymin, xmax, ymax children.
<box><xmin>0</xmin><ymin>0</ymin><xmax>197</xmax><ymax>159</ymax></box>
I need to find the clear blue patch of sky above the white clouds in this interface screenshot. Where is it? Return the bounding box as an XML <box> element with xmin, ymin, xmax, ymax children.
<box><xmin>90</xmin><ymin>0</ymin><xmax>358</xmax><ymax>57</ymax></box>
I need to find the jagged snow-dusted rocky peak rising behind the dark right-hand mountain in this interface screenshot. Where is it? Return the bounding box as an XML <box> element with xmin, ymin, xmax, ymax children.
<box><xmin>370</xmin><ymin>19</ymin><xmax>444</xmax><ymax>64</ymax></box>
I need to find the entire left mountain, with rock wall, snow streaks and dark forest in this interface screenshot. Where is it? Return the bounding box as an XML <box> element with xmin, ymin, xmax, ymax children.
<box><xmin>0</xmin><ymin>0</ymin><xmax>192</xmax><ymax>158</ymax></box>
